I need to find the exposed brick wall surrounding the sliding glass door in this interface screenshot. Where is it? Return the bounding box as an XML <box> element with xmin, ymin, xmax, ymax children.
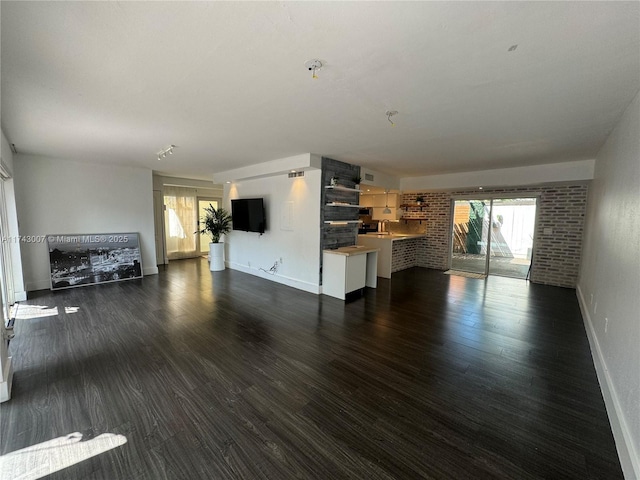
<box><xmin>401</xmin><ymin>184</ymin><xmax>588</xmax><ymax>288</ymax></box>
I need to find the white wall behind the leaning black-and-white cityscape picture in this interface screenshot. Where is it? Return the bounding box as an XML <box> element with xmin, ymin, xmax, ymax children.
<box><xmin>14</xmin><ymin>155</ymin><xmax>158</xmax><ymax>291</ymax></box>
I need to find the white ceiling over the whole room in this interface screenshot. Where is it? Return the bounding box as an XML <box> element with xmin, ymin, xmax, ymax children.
<box><xmin>0</xmin><ymin>1</ymin><xmax>640</xmax><ymax>179</ymax></box>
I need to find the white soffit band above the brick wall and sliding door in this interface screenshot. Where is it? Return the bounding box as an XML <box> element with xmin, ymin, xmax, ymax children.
<box><xmin>400</xmin><ymin>160</ymin><xmax>595</xmax><ymax>192</ymax></box>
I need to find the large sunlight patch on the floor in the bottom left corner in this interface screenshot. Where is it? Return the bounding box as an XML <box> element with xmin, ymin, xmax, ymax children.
<box><xmin>0</xmin><ymin>432</ymin><xmax>127</xmax><ymax>480</ymax></box>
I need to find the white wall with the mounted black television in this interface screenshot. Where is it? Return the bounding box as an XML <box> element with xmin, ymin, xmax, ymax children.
<box><xmin>224</xmin><ymin>170</ymin><xmax>322</xmax><ymax>293</ymax></box>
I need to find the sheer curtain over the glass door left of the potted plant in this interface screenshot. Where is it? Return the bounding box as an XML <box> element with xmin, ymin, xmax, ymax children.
<box><xmin>164</xmin><ymin>185</ymin><xmax>199</xmax><ymax>260</ymax></box>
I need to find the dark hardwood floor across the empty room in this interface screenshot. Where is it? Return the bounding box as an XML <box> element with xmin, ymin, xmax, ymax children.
<box><xmin>0</xmin><ymin>259</ymin><xmax>622</xmax><ymax>480</ymax></box>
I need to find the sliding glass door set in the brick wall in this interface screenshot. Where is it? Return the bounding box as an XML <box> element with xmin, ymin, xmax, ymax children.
<box><xmin>451</xmin><ymin>197</ymin><xmax>537</xmax><ymax>279</ymax></box>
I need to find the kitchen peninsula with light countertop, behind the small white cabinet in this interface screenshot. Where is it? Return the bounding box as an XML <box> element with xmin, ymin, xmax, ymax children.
<box><xmin>358</xmin><ymin>233</ymin><xmax>426</xmax><ymax>278</ymax></box>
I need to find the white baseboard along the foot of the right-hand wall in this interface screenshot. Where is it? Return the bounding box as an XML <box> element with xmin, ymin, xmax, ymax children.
<box><xmin>576</xmin><ymin>285</ymin><xmax>640</xmax><ymax>480</ymax></box>
